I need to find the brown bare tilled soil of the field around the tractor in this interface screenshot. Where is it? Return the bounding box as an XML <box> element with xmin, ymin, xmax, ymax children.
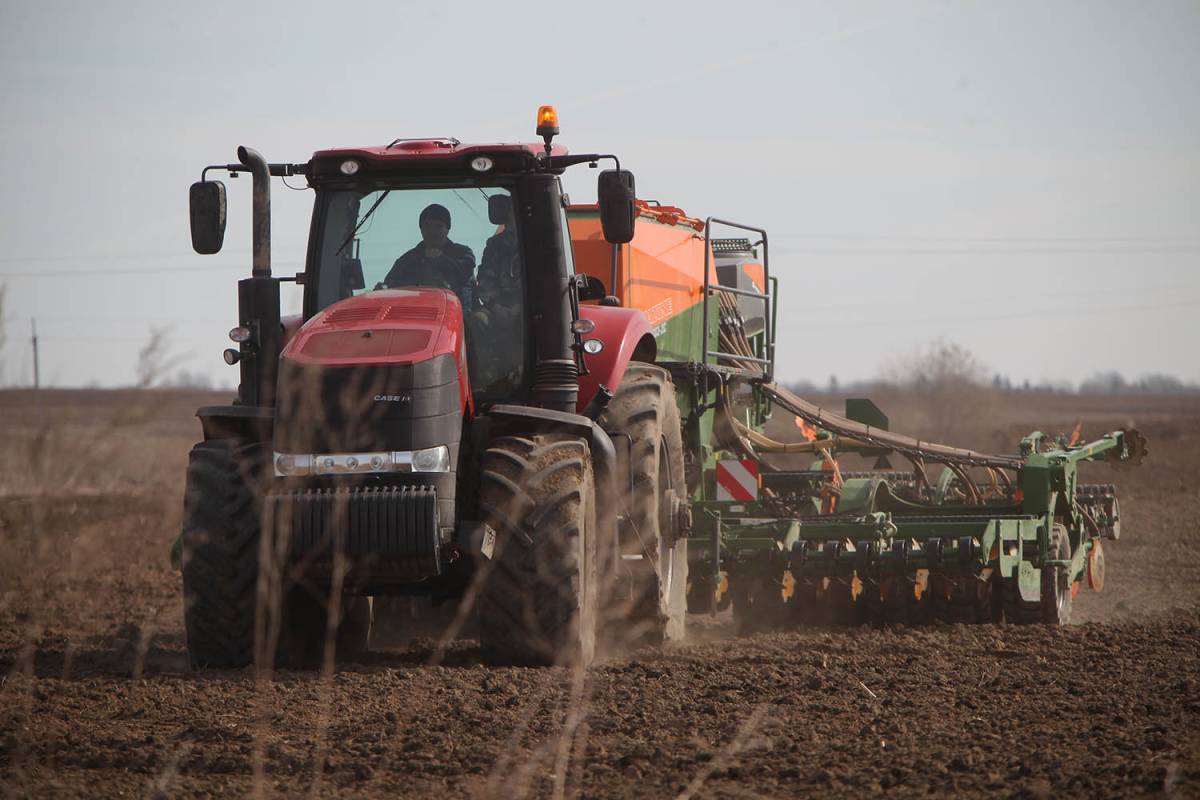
<box><xmin>0</xmin><ymin>392</ymin><xmax>1200</xmax><ymax>798</ymax></box>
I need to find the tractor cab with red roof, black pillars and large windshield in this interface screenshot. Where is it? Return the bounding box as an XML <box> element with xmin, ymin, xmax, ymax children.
<box><xmin>304</xmin><ymin>139</ymin><xmax>559</xmax><ymax>404</ymax></box>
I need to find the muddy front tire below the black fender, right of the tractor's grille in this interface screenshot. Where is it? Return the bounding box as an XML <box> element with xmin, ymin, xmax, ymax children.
<box><xmin>479</xmin><ymin>434</ymin><xmax>598</xmax><ymax>667</ymax></box>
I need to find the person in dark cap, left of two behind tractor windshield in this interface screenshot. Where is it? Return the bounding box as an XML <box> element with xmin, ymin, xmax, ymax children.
<box><xmin>380</xmin><ymin>203</ymin><xmax>475</xmax><ymax>308</ymax></box>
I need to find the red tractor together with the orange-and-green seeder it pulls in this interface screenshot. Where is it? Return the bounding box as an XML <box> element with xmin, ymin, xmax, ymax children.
<box><xmin>179</xmin><ymin>107</ymin><xmax>1146</xmax><ymax>667</ymax></box>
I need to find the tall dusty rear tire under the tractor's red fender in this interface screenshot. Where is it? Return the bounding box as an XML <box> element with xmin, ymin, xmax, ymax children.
<box><xmin>599</xmin><ymin>363</ymin><xmax>688</xmax><ymax>645</ymax></box>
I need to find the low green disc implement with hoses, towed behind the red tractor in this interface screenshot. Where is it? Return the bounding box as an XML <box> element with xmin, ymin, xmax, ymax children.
<box><xmin>692</xmin><ymin>414</ymin><xmax>1145</xmax><ymax>631</ymax></box>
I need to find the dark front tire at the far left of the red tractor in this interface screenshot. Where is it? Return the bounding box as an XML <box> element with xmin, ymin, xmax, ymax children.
<box><xmin>181</xmin><ymin>439</ymin><xmax>265</xmax><ymax>669</ymax></box>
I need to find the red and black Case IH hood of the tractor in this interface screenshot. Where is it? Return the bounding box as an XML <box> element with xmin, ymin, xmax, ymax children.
<box><xmin>274</xmin><ymin>288</ymin><xmax>474</xmax><ymax>506</ymax></box>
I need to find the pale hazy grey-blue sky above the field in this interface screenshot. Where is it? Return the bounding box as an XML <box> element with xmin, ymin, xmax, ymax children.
<box><xmin>0</xmin><ymin>0</ymin><xmax>1200</xmax><ymax>386</ymax></box>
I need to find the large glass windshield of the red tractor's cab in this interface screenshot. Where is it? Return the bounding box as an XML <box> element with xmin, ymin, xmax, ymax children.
<box><xmin>312</xmin><ymin>186</ymin><xmax>527</xmax><ymax>399</ymax></box>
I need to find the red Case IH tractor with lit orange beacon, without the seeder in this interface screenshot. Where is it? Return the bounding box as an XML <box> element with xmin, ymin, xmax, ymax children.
<box><xmin>181</xmin><ymin>107</ymin><xmax>688</xmax><ymax>668</ymax></box>
